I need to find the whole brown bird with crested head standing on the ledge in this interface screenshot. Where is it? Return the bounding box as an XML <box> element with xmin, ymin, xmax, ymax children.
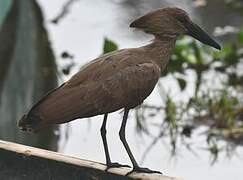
<box><xmin>18</xmin><ymin>8</ymin><xmax>220</xmax><ymax>173</ymax></box>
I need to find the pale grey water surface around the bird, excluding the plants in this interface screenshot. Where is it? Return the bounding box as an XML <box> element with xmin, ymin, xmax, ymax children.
<box><xmin>0</xmin><ymin>0</ymin><xmax>243</xmax><ymax>180</ymax></box>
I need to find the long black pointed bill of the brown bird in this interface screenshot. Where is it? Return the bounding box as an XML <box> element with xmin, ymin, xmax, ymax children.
<box><xmin>186</xmin><ymin>23</ymin><xmax>221</xmax><ymax>50</ymax></box>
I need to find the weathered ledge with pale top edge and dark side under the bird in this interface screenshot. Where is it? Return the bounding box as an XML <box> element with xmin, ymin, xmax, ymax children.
<box><xmin>0</xmin><ymin>140</ymin><xmax>182</xmax><ymax>180</ymax></box>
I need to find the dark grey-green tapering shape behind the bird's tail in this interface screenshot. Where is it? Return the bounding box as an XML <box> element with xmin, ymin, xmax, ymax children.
<box><xmin>0</xmin><ymin>0</ymin><xmax>58</xmax><ymax>150</ymax></box>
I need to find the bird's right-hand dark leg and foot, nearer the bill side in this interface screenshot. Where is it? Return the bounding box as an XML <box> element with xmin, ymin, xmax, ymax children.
<box><xmin>119</xmin><ymin>108</ymin><xmax>161</xmax><ymax>174</ymax></box>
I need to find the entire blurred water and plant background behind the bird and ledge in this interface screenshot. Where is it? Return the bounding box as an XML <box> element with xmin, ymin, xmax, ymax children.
<box><xmin>0</xmin><ymin>0</ymin><xmax>243</xmax><ymax>180</ymax></box>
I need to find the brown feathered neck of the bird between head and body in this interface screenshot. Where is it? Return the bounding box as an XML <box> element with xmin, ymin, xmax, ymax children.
<box><xmin>144</xmin><ymin>36</ymin><xmax>176</xmax><ymax>71</ymax></box>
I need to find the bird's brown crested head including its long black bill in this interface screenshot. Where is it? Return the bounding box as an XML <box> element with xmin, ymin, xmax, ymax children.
<box><xmin>130</xmin><ymin>7</ymin><xmax>220</xmax><ymax>49</ymax></box>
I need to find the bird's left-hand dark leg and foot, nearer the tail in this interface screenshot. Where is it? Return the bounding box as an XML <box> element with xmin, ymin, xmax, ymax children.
<box><xmin>100</xmin><ymin>114</ymin><xmax>130</xmax><ymax>170</ymax></box>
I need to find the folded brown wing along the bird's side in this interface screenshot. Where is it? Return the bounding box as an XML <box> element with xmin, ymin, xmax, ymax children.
<box><xmin>27</xmin><ymin>48</ymin><xmax>160</xmax><ymax>124</ymax></box>
